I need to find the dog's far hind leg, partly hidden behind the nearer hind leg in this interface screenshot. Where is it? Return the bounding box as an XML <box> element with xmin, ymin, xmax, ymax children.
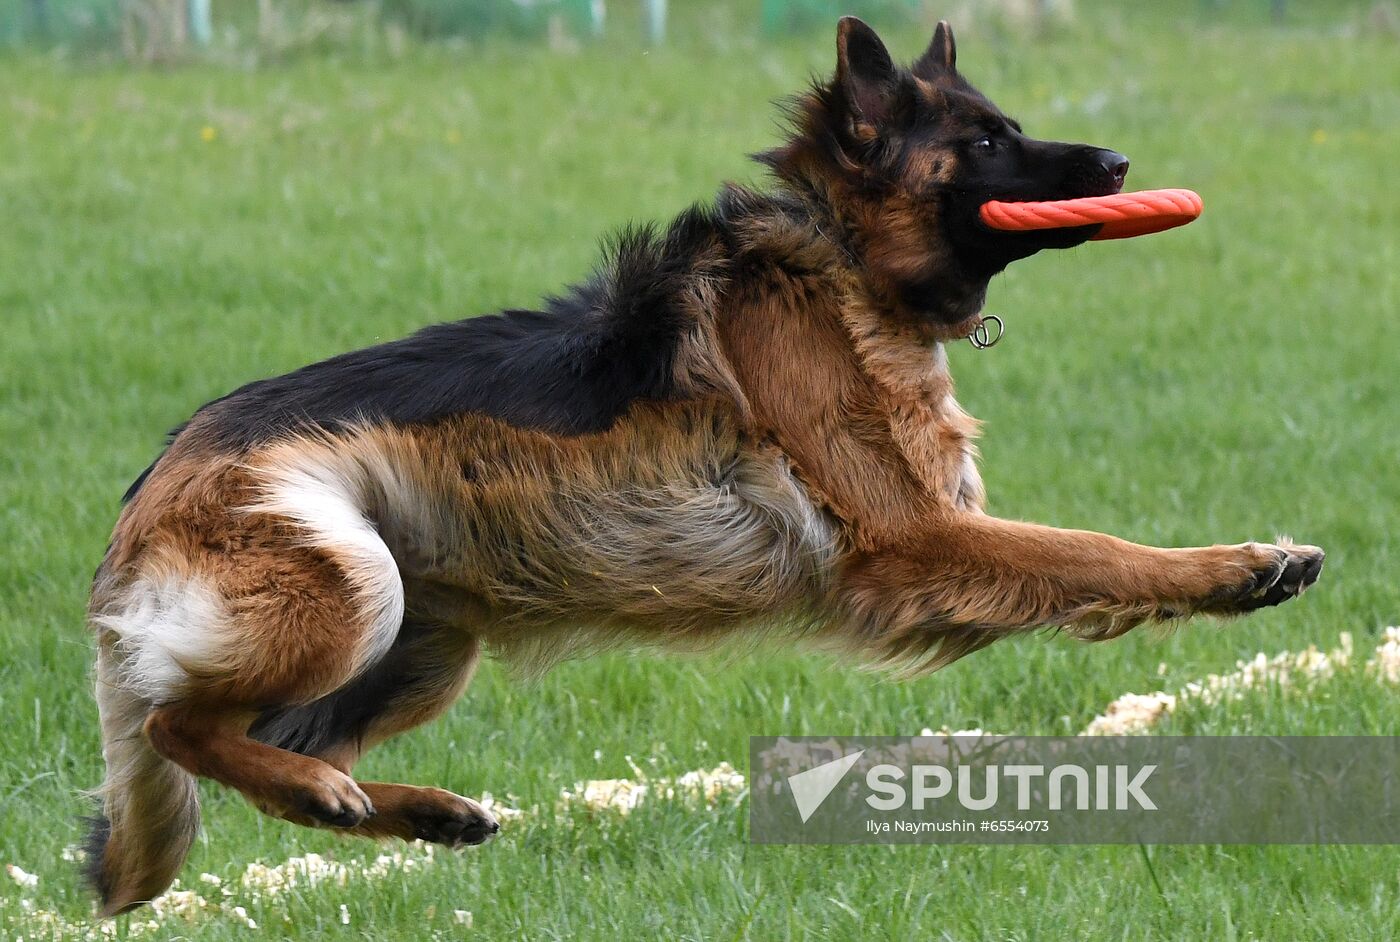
<box><xmin>251</xmin><ymin>617</ymin><xmax>500</xmax><ymax>845</ymax></box>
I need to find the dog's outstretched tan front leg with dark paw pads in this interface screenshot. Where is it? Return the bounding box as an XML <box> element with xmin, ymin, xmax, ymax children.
<box><xmin>837</xmin><ymin>512</ymin><xmax>1323</xmax><ymax>663</ymax></box>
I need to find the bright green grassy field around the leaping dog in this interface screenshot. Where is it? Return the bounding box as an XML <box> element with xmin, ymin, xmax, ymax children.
<box><xmin>0</xmin><ymin>4</ymin><xmax>1400</xmax><ymax>939</ymax></box>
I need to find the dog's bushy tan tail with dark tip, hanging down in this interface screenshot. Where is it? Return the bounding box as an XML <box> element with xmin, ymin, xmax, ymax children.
<box><xmin>87</xmin><ymin>644</ymin><xmax>199</xmax><ymax>915</ymax></box>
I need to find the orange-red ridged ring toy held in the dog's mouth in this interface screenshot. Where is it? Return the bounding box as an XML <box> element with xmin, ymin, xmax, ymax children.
<box><xmin>980</xmin><ymin>190</ymin><xmax>1203</xmax><ymax>241</ymax></box>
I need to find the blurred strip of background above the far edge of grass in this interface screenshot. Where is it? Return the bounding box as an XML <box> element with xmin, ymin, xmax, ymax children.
<box><xmin>0</xmin><ymin>0</ymin><xmax>1400</xmax><ymax>63</ymax></box>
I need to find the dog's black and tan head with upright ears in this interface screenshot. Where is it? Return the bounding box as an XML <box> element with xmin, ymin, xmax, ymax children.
<box><xmin>760</xmin><ymin>17</ymin><xmax>1128</xmax><ymax>323</ymax></box>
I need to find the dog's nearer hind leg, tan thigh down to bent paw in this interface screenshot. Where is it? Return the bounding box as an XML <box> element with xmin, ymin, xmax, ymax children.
<box><xmin>135</xmin><ymin>537</ymin><xmax>402</xmax><ymax>827</ymax></box>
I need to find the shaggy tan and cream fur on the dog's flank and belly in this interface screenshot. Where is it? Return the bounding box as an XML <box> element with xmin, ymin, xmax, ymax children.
<box><xmin>235</xmin><ymin>403</ymin><xmax>834</xmax><ymax>670</ymax></box>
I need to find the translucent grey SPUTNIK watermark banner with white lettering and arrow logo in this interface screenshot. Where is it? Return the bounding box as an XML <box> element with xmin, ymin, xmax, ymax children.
<box><xmin>749</xmin><ymin>736</ymin><xmax>1400</xmax><ymax>843</ymax></box>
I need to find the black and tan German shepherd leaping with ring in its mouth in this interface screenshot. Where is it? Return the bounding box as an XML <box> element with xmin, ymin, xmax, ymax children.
<box><xmin>90</xmin><ymin>18</ymin><xmax>1323</xmax><ymax>914</ymax></box>
